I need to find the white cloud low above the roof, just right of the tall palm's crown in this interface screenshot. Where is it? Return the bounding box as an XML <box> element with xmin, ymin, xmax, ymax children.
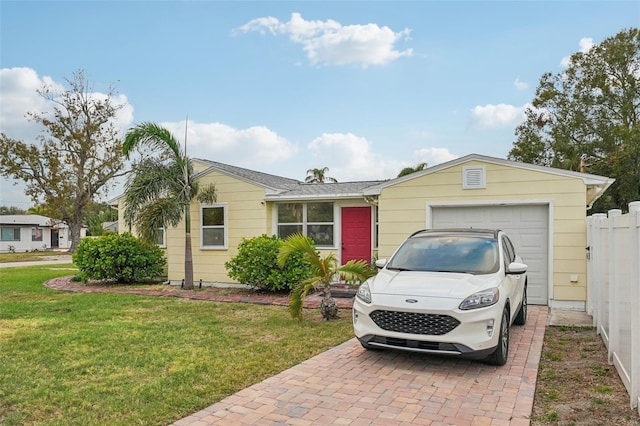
<box><xmin>160</xmin><ymin>121</ymin><xmax>298</xmax><ymax>167</ymax></box>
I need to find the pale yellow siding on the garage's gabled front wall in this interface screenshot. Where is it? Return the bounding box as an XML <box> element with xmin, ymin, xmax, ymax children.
<box><xmin>379</xmin><ymin>161</ymin><xmax>587</xmax><ymax>301</ymax></box>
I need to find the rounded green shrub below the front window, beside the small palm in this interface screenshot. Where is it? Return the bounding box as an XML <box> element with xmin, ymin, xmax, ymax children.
<box><xmin>224</xmin><ymin>234</ymin><xmax>311</xmax><ymax>292</ymax></box>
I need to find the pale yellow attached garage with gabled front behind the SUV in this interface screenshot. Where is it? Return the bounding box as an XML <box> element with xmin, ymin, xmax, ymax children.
<box><xmin>364</xmin><ymin>154</ymin><xmax>613</xmax><ymax>310</ymax></box>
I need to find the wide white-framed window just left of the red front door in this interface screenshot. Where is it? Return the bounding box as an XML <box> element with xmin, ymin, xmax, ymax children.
<box><xmin>278</xmin><ymin>203</ymin><xmax>334</xmax><ymax>247</ymax></box>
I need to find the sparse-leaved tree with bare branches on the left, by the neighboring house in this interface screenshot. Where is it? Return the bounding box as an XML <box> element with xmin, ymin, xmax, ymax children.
<box><xmin>0</xmin><ymin>71</ymin><xmax>129</xmax><ymax>252</ymax></box>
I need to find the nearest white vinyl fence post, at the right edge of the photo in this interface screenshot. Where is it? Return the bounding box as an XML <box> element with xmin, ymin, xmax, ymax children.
<box><xmin>629</xmin><ymin>201</ymin><xmax>640</xmax><ymax>414</ymax></box>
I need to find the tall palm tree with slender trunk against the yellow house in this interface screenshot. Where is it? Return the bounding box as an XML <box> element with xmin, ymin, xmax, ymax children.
<box><xmin>122</xmin><ymin>122</ymin><xmax>216</xmax><ymax>290</ymax></box>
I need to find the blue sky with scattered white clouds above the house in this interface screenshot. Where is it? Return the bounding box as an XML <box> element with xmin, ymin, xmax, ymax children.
<box><xmin>0</xmin><ymin>0</ymin><xmax>640</xmax><ymax>209</ymax></box>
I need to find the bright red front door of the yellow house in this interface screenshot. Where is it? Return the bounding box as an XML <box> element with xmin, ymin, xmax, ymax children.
<box><xmin>341</xmin><ymin>207</ymin><xmax>371</xmax><ymax>264</ymax></box>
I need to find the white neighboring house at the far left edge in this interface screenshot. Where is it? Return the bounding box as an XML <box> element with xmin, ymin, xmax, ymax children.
<box><xmin>0</xmin><ymin>214</ymin><xmax>86</xmax><ymax>253</ymax></box>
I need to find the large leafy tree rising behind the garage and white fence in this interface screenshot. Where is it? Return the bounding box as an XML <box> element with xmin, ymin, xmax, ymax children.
<box><xmin>509</xmin><ymin>28</ymin><xmax>640</xmax><ymax>211</ymax></box>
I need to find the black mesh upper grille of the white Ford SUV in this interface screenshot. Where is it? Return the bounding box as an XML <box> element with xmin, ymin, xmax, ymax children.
<box><xmin>369</xmin><ymin>310</ymin><xmax>460</xmax><ymax>336</ymax></box>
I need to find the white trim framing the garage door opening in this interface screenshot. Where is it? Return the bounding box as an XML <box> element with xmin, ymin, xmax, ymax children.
<box><xmin>425</xmin><ymin>199</ymin><xmax>556</xmax><ymax>310</ymax></box>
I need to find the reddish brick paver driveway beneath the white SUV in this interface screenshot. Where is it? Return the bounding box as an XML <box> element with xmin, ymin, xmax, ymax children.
<box><xmin>174</xmin><ymin>306</ymin><xmax>548</xmax><ymax>426</ymax></box>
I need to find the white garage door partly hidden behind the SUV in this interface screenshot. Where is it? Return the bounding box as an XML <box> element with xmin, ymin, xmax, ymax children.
<box><xmin>432</xmin><ymin>205</ymin><xmax>549</xmax><ymax>305</ymax></box>
